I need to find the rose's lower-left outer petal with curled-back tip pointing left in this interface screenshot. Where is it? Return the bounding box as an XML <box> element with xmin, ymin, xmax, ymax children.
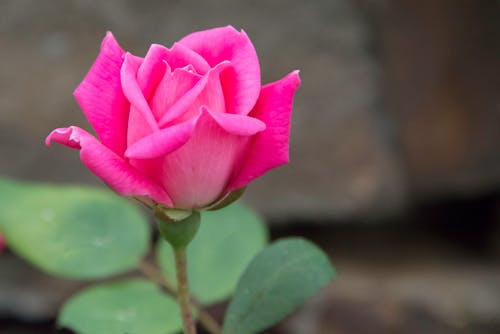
<box><xmin>45</xmin><ymin>126</ymin><xmax>172</xmax><ymax>206</ymax></box>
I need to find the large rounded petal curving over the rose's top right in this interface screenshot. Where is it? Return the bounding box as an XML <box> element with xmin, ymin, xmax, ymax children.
<box><xmin>179</xmin><ymin>26</ymin><xmax>260</xmax><ymax>115</ymax></box>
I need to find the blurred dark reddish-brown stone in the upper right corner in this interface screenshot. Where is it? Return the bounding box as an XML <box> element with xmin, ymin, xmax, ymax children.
<box><xmin>375</xmin><ymin>0</ymin><xmax>500</xmax><ymax>197</ymax></box>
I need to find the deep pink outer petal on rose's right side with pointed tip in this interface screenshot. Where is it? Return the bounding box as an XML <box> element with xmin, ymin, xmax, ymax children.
<box><xmin>228</xmin><ymin>71</ymin><xmax>300</xmax><ymax>191</ymax></box>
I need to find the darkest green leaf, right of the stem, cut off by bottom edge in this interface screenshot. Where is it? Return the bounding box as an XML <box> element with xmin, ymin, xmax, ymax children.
<box><xmin>223</xmin><ymin>238</ymin><xmax>335</xmax><ymax>334</ymax></box>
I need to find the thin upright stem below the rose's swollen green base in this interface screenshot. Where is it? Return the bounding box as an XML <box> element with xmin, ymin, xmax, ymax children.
<box><xmin>174</xmin><ymin>247</ymin><xmax>196</xmax><ymax>334</ymax></box>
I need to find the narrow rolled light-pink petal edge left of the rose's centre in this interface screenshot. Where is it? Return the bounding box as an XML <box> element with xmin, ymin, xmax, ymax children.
<box><xmin>120</xmin><ymin>52</ymin><xmax>158</xmax><ymax>131</ymax></box>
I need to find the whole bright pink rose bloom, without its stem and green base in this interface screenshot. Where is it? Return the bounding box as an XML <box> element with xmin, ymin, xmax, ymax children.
<box><xmin>46</xmin><ymin>26</ymin><xmax>300</xmax><ymax>209</ymax></box>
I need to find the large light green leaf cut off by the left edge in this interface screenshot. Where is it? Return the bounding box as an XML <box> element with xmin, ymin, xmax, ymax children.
<box><xmin>0</xmin><ymin>180</ymin><xmax>150</xmax><ymax>279</ymax></box>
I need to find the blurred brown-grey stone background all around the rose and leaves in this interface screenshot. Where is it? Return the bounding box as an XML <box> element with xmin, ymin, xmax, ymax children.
<box><xmin>0</xmin><ymin>0</ymin><xmax>500</xmax><ymax>334</ymax></box>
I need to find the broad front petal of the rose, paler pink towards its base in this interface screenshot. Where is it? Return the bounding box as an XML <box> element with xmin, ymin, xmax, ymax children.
<box><xmin>158</xmin><ymin>109</ymin><xmax>254</xmax><ymax>209</ymax></box>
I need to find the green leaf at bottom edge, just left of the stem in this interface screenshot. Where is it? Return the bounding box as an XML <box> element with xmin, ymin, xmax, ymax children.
<box><xmin>58</xmin><ymin>279</ymin><xmax>182</xmax><ymax>334</ymax></box>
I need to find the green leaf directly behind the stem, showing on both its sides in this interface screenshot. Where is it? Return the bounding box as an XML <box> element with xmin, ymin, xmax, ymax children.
<box><xmin>158</xmin><ymin>203</ymin><xmax>267</xmax><ymax>304</ymax></box>
